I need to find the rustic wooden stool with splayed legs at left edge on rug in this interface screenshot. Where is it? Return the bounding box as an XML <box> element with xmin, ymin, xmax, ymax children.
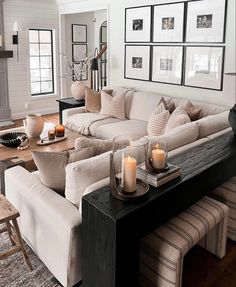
<box><xmin>0</xmin><ymin>194</ymin><xmax>33</xmax><ymax>271</ymax></box>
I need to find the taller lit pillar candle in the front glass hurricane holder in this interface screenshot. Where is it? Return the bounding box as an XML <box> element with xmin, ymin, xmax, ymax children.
<box><xmin>122</xmin><ymin>156</ymin><xmax>137</xmax><ymax>195</ymax></box>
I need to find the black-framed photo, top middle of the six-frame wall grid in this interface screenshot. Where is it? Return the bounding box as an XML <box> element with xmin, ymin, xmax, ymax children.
<box><xmin>152</xmin><ymin>1</ymin><xmax>186</xmax><ymax>44</ymax></box>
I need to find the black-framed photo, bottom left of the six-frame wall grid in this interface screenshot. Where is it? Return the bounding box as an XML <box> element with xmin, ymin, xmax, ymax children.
<box><xmin>125</xmin><ymin>45</ymin><xmax>150</xmax><ymax>81</ymax></box>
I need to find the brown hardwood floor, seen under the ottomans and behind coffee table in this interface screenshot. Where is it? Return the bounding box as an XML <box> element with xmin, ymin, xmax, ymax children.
<box><xmin>0</xmin><ymin>113</ymin><xmax>236</xmax><ymax>287</ymax></box>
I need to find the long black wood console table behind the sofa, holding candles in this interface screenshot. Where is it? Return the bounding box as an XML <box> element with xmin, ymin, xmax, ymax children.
<box><xmin>82</xmin><ymin>132</ymin><xmax>236</xmax><ymax>287</ymax></box>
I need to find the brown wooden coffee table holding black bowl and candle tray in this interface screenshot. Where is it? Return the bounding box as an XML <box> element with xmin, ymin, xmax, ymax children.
<box><xmin>0</xmin><ymin>127</ymin><xmax>82</xmax><ymax>194</ymax></box>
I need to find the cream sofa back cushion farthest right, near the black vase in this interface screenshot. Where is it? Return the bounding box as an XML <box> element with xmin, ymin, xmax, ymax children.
<box><xmin>196</xmin><ymin>111</ymin><xmax>229</xmax><ymax>138</ymax></box>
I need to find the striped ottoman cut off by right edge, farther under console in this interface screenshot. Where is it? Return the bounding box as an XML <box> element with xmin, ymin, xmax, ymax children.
<box><xmin>209</xmin><ymin>176</ymin><xmax>236</xmax><ymax>241</ymax></box>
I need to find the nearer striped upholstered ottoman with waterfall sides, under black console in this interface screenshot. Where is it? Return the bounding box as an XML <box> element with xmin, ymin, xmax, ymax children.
<box><xmin>139</xmin><ymin>196</ymin><xmax>229</xmax><ymax>287</ymax></box>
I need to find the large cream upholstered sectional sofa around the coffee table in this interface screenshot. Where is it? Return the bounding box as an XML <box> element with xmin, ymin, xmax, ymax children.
<box><xmin>5</xmin><ymin>89</ymin><xmax>230</xmax><ymax>286</ymax></box>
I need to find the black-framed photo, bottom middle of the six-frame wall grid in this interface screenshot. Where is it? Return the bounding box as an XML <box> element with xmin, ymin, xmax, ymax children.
<box><xmin>150</xmin><ymin>45</ymin><xmax>185</xmax><ymax>86</ymax></box>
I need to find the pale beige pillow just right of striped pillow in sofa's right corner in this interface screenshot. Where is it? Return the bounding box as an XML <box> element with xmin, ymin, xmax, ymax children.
<box><xmin>164</xmin><ymin>107</ymin><xmax>191</xmax><ymax>134</ymax></box>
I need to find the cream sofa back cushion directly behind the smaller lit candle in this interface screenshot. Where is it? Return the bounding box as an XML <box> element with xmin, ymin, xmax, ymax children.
<box><xmin>148</xmin><ymin>122</ymin><xmax>198</xmax><ymax>151</ymax></box>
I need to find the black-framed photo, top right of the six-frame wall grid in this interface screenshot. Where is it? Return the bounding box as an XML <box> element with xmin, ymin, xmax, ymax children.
<box><xmin>186</xmin><ymin>0</ymin><xmax>227</xmax><ymax>43</ymax></box>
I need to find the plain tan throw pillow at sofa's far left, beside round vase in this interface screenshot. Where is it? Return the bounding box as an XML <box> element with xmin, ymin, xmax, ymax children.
<box><xmin>85</xmin><ymin>87</ymin><xmax>101</xmax><ymax>113</ymax></box>
